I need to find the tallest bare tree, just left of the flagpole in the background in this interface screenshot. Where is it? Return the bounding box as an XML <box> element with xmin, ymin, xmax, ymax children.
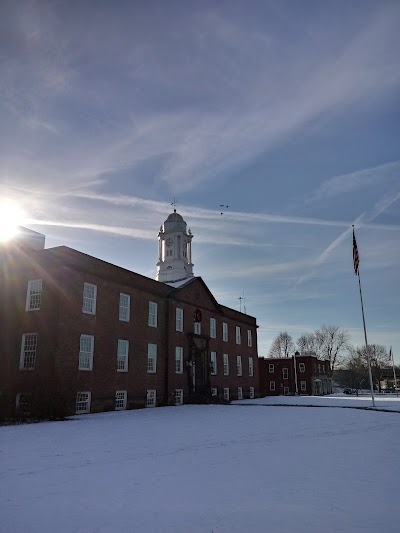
<box><xmin>315</xmin><ymin>326</ymin><xmax>350</xmax><ymax>370</ymax></box>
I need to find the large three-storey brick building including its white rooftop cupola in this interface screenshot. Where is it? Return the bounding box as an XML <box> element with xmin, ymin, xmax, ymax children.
<box><xmin>0</xmin><ymin>211</ymin><xmax>259</xmax><ymax>414</ymax></box>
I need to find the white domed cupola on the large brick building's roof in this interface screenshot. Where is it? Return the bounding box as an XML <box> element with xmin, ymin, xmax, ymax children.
<box><xmin>156</xmin><ymin>209</ymin><xmax>193</xmax><ymax>282</ymax></box>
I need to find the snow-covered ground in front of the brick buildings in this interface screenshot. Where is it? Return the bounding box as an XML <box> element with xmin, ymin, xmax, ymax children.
<box><xmin>0</xmin><ymin>396</ymin><xmax>400</xmax><ymax>533</ymax></box>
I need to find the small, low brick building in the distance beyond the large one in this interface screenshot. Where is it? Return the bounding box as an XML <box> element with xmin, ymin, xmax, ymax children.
<box><xmin>258</xmin><ymin>352</ymin><xmax>332</xmax><ymax>396</ymax></box>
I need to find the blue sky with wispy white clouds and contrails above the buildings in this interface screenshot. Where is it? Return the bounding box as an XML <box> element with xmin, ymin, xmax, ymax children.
<box><xmin>0</xmin><ymin>0</ymin><xmax>400</xmax><ymax>363</ymax></box>
